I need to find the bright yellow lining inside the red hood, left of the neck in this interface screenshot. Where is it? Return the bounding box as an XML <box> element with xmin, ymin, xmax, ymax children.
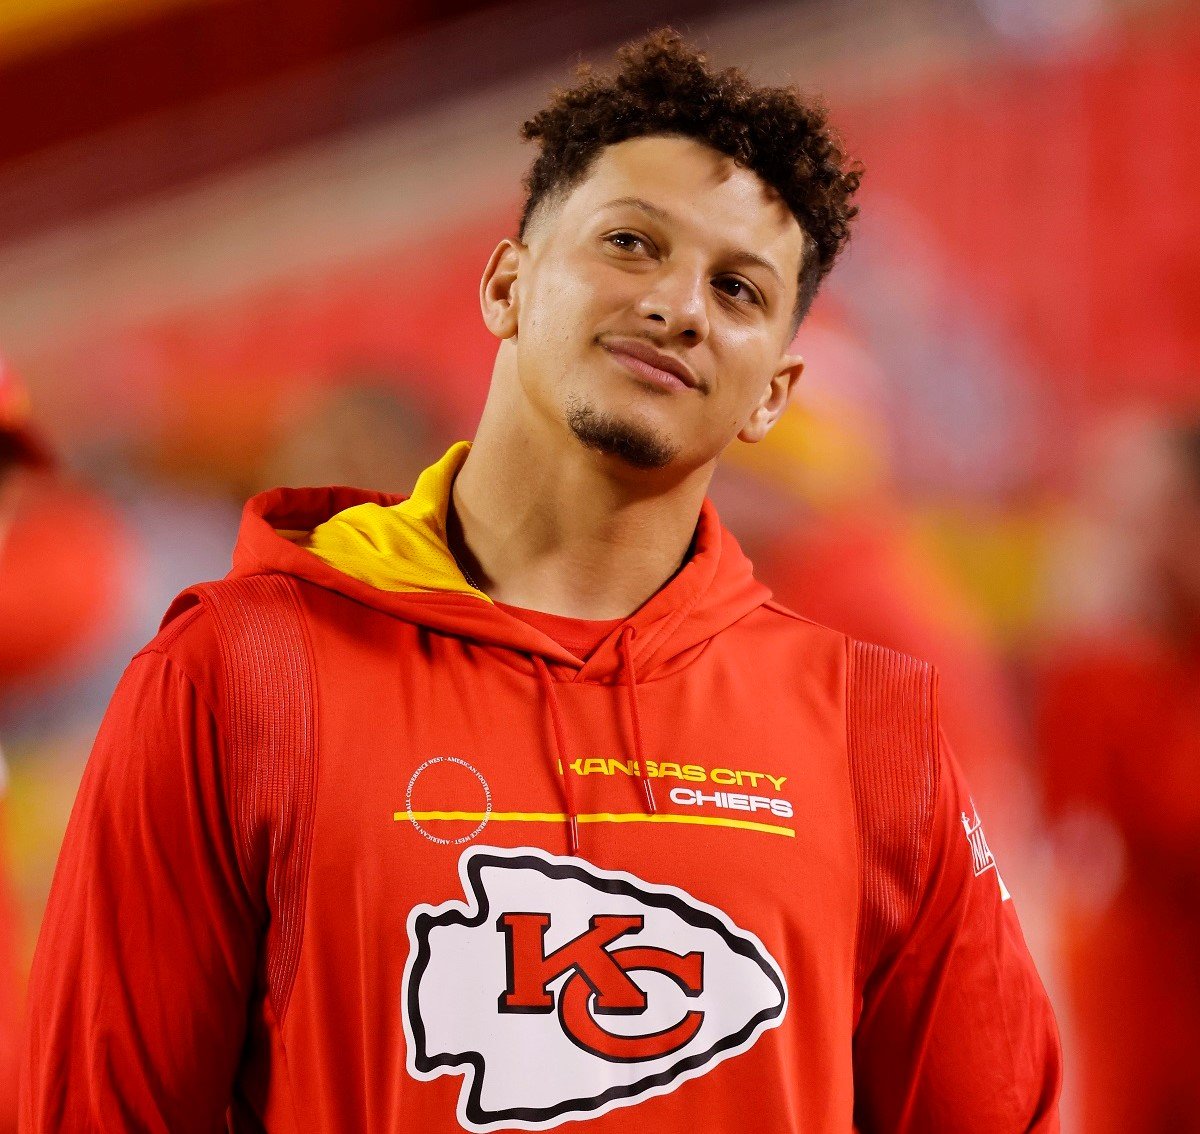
<box><xmin>280</xmin><ymin>442</ymin><xmax>492</xmax><ymax>602</ymax></box>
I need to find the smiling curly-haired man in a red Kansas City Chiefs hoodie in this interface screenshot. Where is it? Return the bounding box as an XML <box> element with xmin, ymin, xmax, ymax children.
<box><xmin>23</xmin><ymin>32</ymin><xmax>1058</xmax><ymax>1132</ymax></box>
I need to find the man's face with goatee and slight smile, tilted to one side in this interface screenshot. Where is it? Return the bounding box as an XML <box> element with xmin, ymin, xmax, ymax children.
<box><xmin>485</xmin><ymin>136</ymin><xmax>804</xmax><ymax>472</ymax></box>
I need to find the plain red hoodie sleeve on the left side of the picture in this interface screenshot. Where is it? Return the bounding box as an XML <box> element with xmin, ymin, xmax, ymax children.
<box><xmin>20</xmin><ymin>619</ymin><xmax>263</xmax><ymax>1134</ymax></box>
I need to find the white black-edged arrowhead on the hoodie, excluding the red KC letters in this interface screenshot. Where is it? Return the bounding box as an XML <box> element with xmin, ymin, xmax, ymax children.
<box><xmin>402</xmin><ymin>845</ymin><xmax>787</xmax><ymax>1132</ymax></box>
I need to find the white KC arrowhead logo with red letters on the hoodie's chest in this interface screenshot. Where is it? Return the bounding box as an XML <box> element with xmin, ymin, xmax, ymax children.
<box><xmin>402</xmin><ymin>846</ymin><xmax>787</xmax><ymax>1132</ymax></box>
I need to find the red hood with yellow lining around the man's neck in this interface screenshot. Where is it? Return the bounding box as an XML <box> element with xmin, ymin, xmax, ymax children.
<box><xmin>224</xmin><ymin>442</ymin><xmax>770</xmax><ymax>682</ymax></box>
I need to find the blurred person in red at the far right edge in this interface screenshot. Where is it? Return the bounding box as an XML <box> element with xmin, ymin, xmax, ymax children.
<box><xmin>1039</xmin><ymin>421</ymin><xmax>1200</xmax><ymax>1134</ymax></box>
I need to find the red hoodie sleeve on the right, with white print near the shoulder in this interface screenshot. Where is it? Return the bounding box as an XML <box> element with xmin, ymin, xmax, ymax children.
<box><xmin>854</xmin><ymin>731</ymin><xmax>1062</xmax><ymax>1134</ymax></box>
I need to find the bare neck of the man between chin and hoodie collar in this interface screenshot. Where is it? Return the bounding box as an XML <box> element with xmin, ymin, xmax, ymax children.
<box><xmin>446</xmin><ymin>386</ymin><xmax>713</xmax><ymax>619</ymax></box>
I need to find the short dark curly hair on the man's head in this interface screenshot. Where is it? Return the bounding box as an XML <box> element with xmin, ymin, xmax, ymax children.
<box><xmin>518</xmin><ymin>28</ymin><xmax>863</xmax><ymax>325</ymax></box>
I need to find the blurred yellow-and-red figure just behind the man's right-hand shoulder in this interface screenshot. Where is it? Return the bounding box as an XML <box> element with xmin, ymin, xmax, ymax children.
<box><xmin>718</xmin><ymin>376</ymin><xmax>1039</xmax><ymax>864</ymax></box>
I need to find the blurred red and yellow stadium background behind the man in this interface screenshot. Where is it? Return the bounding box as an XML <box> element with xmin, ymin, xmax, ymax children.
<box><xmin>0</xmin><ymin>0</ymin><xmax>1200</xmax><ymax>1134</ymax></box>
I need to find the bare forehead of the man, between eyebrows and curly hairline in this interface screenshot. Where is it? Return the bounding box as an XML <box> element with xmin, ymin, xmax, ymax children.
<box><xmin>560</xmin><ymin>136</ymin><xmax>804</xmax><ymax>272</ymax></box>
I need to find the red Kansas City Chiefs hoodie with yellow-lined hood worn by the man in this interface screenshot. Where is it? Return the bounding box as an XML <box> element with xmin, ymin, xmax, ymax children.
<box><xmin>22</xmin><ymin>446</ymin><xmax>1060</xmax><ymax>1134</ymax></box>
